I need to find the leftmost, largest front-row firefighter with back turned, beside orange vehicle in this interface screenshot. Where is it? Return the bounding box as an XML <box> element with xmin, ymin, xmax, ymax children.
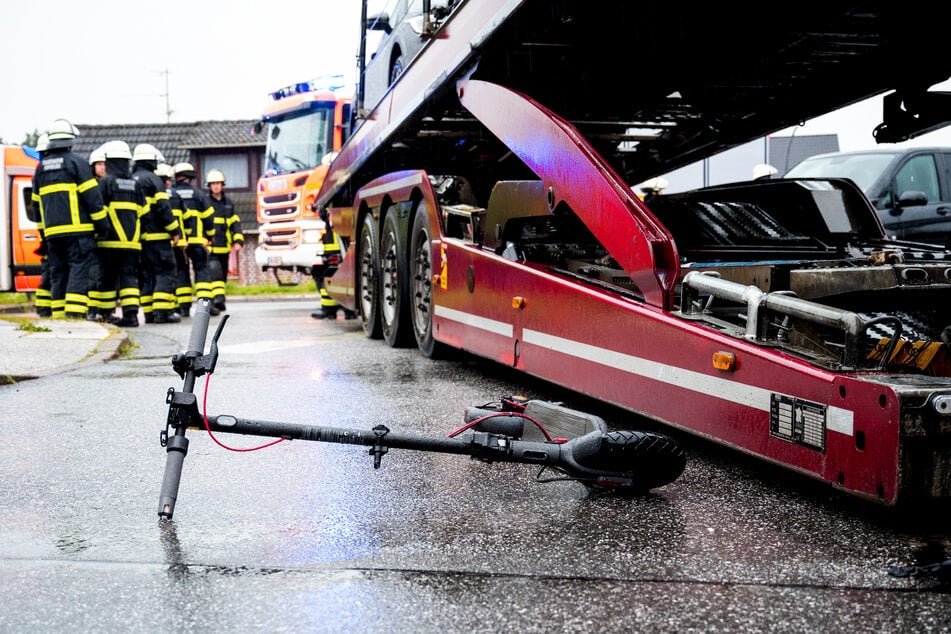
<box><xmin>32</xmin><ymin>119</ymin><xmax>109</xmax><ymax>319</ymax></box>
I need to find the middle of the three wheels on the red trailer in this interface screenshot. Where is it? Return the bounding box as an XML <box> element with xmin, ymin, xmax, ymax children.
<box><xmin>379</xmin><ymin>213</ymin><xmax>410</xmax><ymax>348</ymax></box>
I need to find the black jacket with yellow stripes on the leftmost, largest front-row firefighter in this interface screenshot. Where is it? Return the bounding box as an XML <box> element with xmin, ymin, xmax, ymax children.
<box><xmin>32</xmin><ymin>148</ymin><xmax>108</xmax><ymax>240</ymax></box>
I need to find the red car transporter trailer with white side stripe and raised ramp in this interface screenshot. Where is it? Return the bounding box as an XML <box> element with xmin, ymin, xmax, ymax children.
<box><xmin>315</xmin><ymin>0</ymin><xmax>951</xmax><ymax>507</ymax></box>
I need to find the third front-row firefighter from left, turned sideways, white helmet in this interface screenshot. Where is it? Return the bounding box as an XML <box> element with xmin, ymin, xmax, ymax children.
<box><xmin>132</xmin><ymin>143</ymin><xmax>182</xmax><ymax>324</ymax></box>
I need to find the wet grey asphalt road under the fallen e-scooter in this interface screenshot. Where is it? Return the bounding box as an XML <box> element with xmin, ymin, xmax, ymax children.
<box><xmin>0</xmin><ymin>301</ymin><xmax>951</xmax><ymax>632</ymax></box>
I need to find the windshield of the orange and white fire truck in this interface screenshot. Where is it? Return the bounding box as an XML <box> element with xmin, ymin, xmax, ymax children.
<box><xmin>265</xmin><ymin>102</ymin><xmax>334</xmax><ymax>176</ymax></box>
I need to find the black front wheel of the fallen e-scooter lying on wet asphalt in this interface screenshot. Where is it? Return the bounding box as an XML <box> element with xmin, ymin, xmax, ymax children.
<box><xmin>579</xmin><ymin>431</ymin><xmax>687</xmax><ymax>494</ymax></box>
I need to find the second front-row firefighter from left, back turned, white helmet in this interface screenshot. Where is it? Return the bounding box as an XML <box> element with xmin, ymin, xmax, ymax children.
<box><xmin>88</xmin><ymin>141</ymin><xmax>147</xmax><ymax>328</ymax></box>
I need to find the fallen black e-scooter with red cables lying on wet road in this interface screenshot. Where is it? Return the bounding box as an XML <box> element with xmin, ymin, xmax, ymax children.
<box><xmin>158</xmin><ymin>299</ymin><xmax>686</xmax><ymax>518</ymax></box>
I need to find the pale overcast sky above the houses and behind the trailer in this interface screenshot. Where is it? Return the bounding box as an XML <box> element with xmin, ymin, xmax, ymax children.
<box><xmin>0</xmin><ymin>0</ymin><xmax>951</xmax><ymax>150</ymax></box>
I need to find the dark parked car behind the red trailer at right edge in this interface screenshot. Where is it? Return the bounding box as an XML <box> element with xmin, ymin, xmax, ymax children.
<box><xmin>784</xmin><ymin>147</ymin><xmax>951</xmax><ymax>247</ymax></box>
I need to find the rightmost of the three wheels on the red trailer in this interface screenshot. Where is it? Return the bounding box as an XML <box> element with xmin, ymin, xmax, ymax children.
<box><xmin>409</xmin><ymin>205</ymin><xmax>449</xmax><ymax>359</ymax></box>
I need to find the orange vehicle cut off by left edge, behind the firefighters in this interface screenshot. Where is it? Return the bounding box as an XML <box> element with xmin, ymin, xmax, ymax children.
<box><xmin>0</xmin><ymin>145</ymin><xmax>41</xmax><ymax>292</ymax></box>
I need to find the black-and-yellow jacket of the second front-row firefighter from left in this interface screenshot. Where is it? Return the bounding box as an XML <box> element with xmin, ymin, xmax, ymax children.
<box><xmin>96</xmin><ymin>158</ymin><xmax>147</xmax><ymax>251</ymax></box>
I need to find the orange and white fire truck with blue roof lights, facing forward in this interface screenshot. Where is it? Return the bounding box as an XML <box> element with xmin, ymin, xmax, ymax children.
<box><xmin>252</xmin><ymin>75</ymin><xmax>353</xmax><ymax>284</ymax></box>
